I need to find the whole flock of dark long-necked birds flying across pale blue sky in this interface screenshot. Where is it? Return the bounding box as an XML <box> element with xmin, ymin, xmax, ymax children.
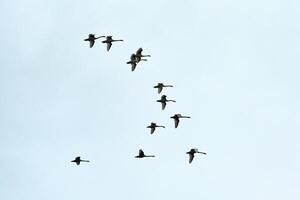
<box><xmin>71</xmin><ymin>34</ymin><xmax>206</xmax><ymax>165</ymax></box>
